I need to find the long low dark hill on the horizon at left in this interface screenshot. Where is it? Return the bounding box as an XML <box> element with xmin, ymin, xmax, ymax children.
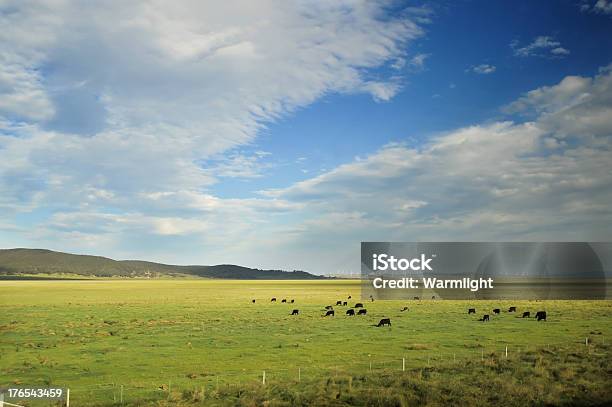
<box><xmin>0</xmin><ymin>249</ymin><xmax>325</xmax><ymax>280</ymax></box>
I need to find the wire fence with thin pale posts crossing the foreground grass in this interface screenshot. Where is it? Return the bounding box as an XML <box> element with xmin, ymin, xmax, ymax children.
<box><xmin>7</xmin><ymin>335</ymin><xmax>609</xmax><ymax>407</ymax></box>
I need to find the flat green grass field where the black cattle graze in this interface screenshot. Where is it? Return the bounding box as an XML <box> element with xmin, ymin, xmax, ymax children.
<box><xmin>0</xmin><ymin>280</ymin><xmax>612</xmax><ymax>406</ymax></box>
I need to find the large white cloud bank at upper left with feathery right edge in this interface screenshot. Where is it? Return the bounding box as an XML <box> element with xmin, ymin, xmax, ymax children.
<box><xmin>0</xmin><ymin>0</ymin><xmax>422</xmax><ymax>213</ymax></box>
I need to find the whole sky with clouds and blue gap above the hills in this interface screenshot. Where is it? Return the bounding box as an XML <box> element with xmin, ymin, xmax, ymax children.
<box><xmin>0</xmin><ymin>0</ymin><xmax>612</xmax><ymax>274</ymax></box>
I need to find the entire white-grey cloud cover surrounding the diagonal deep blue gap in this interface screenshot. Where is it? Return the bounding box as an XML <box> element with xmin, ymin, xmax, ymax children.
<box><xmin>0</xmin><ymin>1</ymin><xmax>612</xmax><ymax>272</ymax></box>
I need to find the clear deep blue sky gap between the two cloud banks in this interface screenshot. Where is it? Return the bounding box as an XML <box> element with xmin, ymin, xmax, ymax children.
<box><xmin>209</xmin><ymin>1</ymin><xmax>612</xmax><ymax>197</ymax></box>
